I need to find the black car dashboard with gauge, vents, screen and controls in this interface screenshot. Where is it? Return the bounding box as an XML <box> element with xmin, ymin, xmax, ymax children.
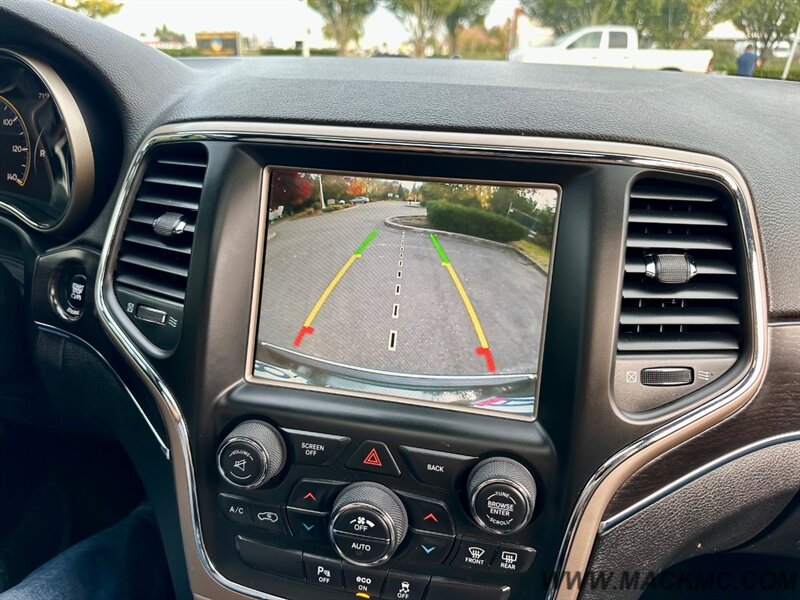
<box><xmin>0</xmin><ymin>1</ymin><xmax>800</xmax><ymax>600</ymax></box>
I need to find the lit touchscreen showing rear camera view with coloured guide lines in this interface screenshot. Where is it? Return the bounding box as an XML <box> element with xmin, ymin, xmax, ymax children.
<box><xmin>252</xmin><ymin>169</ymin><xmax>559</xmax><ymax>418</ymax></box>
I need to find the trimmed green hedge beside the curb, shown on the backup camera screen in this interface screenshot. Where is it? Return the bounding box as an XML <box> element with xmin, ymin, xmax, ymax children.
<box><xmin>427</xmin><ymin>201</ymin><xmax>527</xmax><ymax>242</ymax></box>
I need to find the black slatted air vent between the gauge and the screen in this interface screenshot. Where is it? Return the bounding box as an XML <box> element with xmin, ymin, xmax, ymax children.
<box><xmin>114</xmin><ymin>143</ymin><xmax>208</xmax><ymax>304</ymax></box>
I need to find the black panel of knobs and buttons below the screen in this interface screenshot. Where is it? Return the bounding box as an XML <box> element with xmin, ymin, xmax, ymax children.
<box><xmin>209</xmin><ymin>419</ymin><xmax>537</xmax><ymax>600</ymax></box>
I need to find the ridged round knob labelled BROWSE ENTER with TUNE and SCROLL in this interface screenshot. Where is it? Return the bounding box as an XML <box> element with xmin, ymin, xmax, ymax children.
<box><xmin>467</xmin><ymin>458</ymin><xmax>536</xmax><ymax>535</ymax></box>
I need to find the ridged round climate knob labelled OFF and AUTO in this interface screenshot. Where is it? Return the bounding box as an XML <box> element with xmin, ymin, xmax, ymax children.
<box><xmin>329</xmin><ymin>482</ymin><xmax>408</xmax><ymax>567</ymax></box>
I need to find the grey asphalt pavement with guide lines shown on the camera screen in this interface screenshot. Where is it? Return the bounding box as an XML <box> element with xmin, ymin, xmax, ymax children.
<box><xmin>258</xmin><ymin>202</ymin><xmax>546</xmax><ymax>375</ymax></box>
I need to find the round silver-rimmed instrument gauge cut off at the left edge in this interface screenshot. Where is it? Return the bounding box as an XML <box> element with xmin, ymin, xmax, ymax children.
<box><xmin>0</xmin><ymin>49</ymin><xmax>94</xmax><ymax>232</ymax></box>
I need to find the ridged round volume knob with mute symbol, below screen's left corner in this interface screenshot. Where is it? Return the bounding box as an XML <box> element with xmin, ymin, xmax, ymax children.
<box><xmin>217</xmin><ymin>421</ymin><xmax>286</xmax><ymax>490</ymax></box>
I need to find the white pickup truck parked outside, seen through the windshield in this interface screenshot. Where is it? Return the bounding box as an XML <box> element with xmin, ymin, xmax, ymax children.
<box><xmin>508</xmin><ymin>25</ymin><xmax>714</xmax><ymax>73</ymax></box>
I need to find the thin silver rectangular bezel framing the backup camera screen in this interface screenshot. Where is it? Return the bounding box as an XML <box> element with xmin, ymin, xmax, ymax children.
<box><xmin>244</xmin><ymin>164</ymin><xmax>564</xmax><ymax>422</ymax></box>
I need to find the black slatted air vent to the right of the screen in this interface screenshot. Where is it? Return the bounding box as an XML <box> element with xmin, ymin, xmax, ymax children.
<box><xmin>617</xmin><ymin>178</ymin><xmax>742</xmax><ymax>354</ymax></box>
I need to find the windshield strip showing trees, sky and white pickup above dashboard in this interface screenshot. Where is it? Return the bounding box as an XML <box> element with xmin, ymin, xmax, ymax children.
<box><xmin>52</xmin><ymin>0</ymin><xmax>800</xmax><ymax>80</ymax></box>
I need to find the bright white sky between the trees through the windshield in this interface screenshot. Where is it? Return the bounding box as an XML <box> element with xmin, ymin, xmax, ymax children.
<box><xmin>103</xmin><ymin>0</ymin><xmax>519</xmax><ymax>48</ymax></box>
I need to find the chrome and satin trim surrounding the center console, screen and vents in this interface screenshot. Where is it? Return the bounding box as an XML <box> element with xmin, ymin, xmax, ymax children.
<box><xmin>95</xmin><ymin>122</ymin><xmax>768</xmax><ymax>600</ymax></box>
